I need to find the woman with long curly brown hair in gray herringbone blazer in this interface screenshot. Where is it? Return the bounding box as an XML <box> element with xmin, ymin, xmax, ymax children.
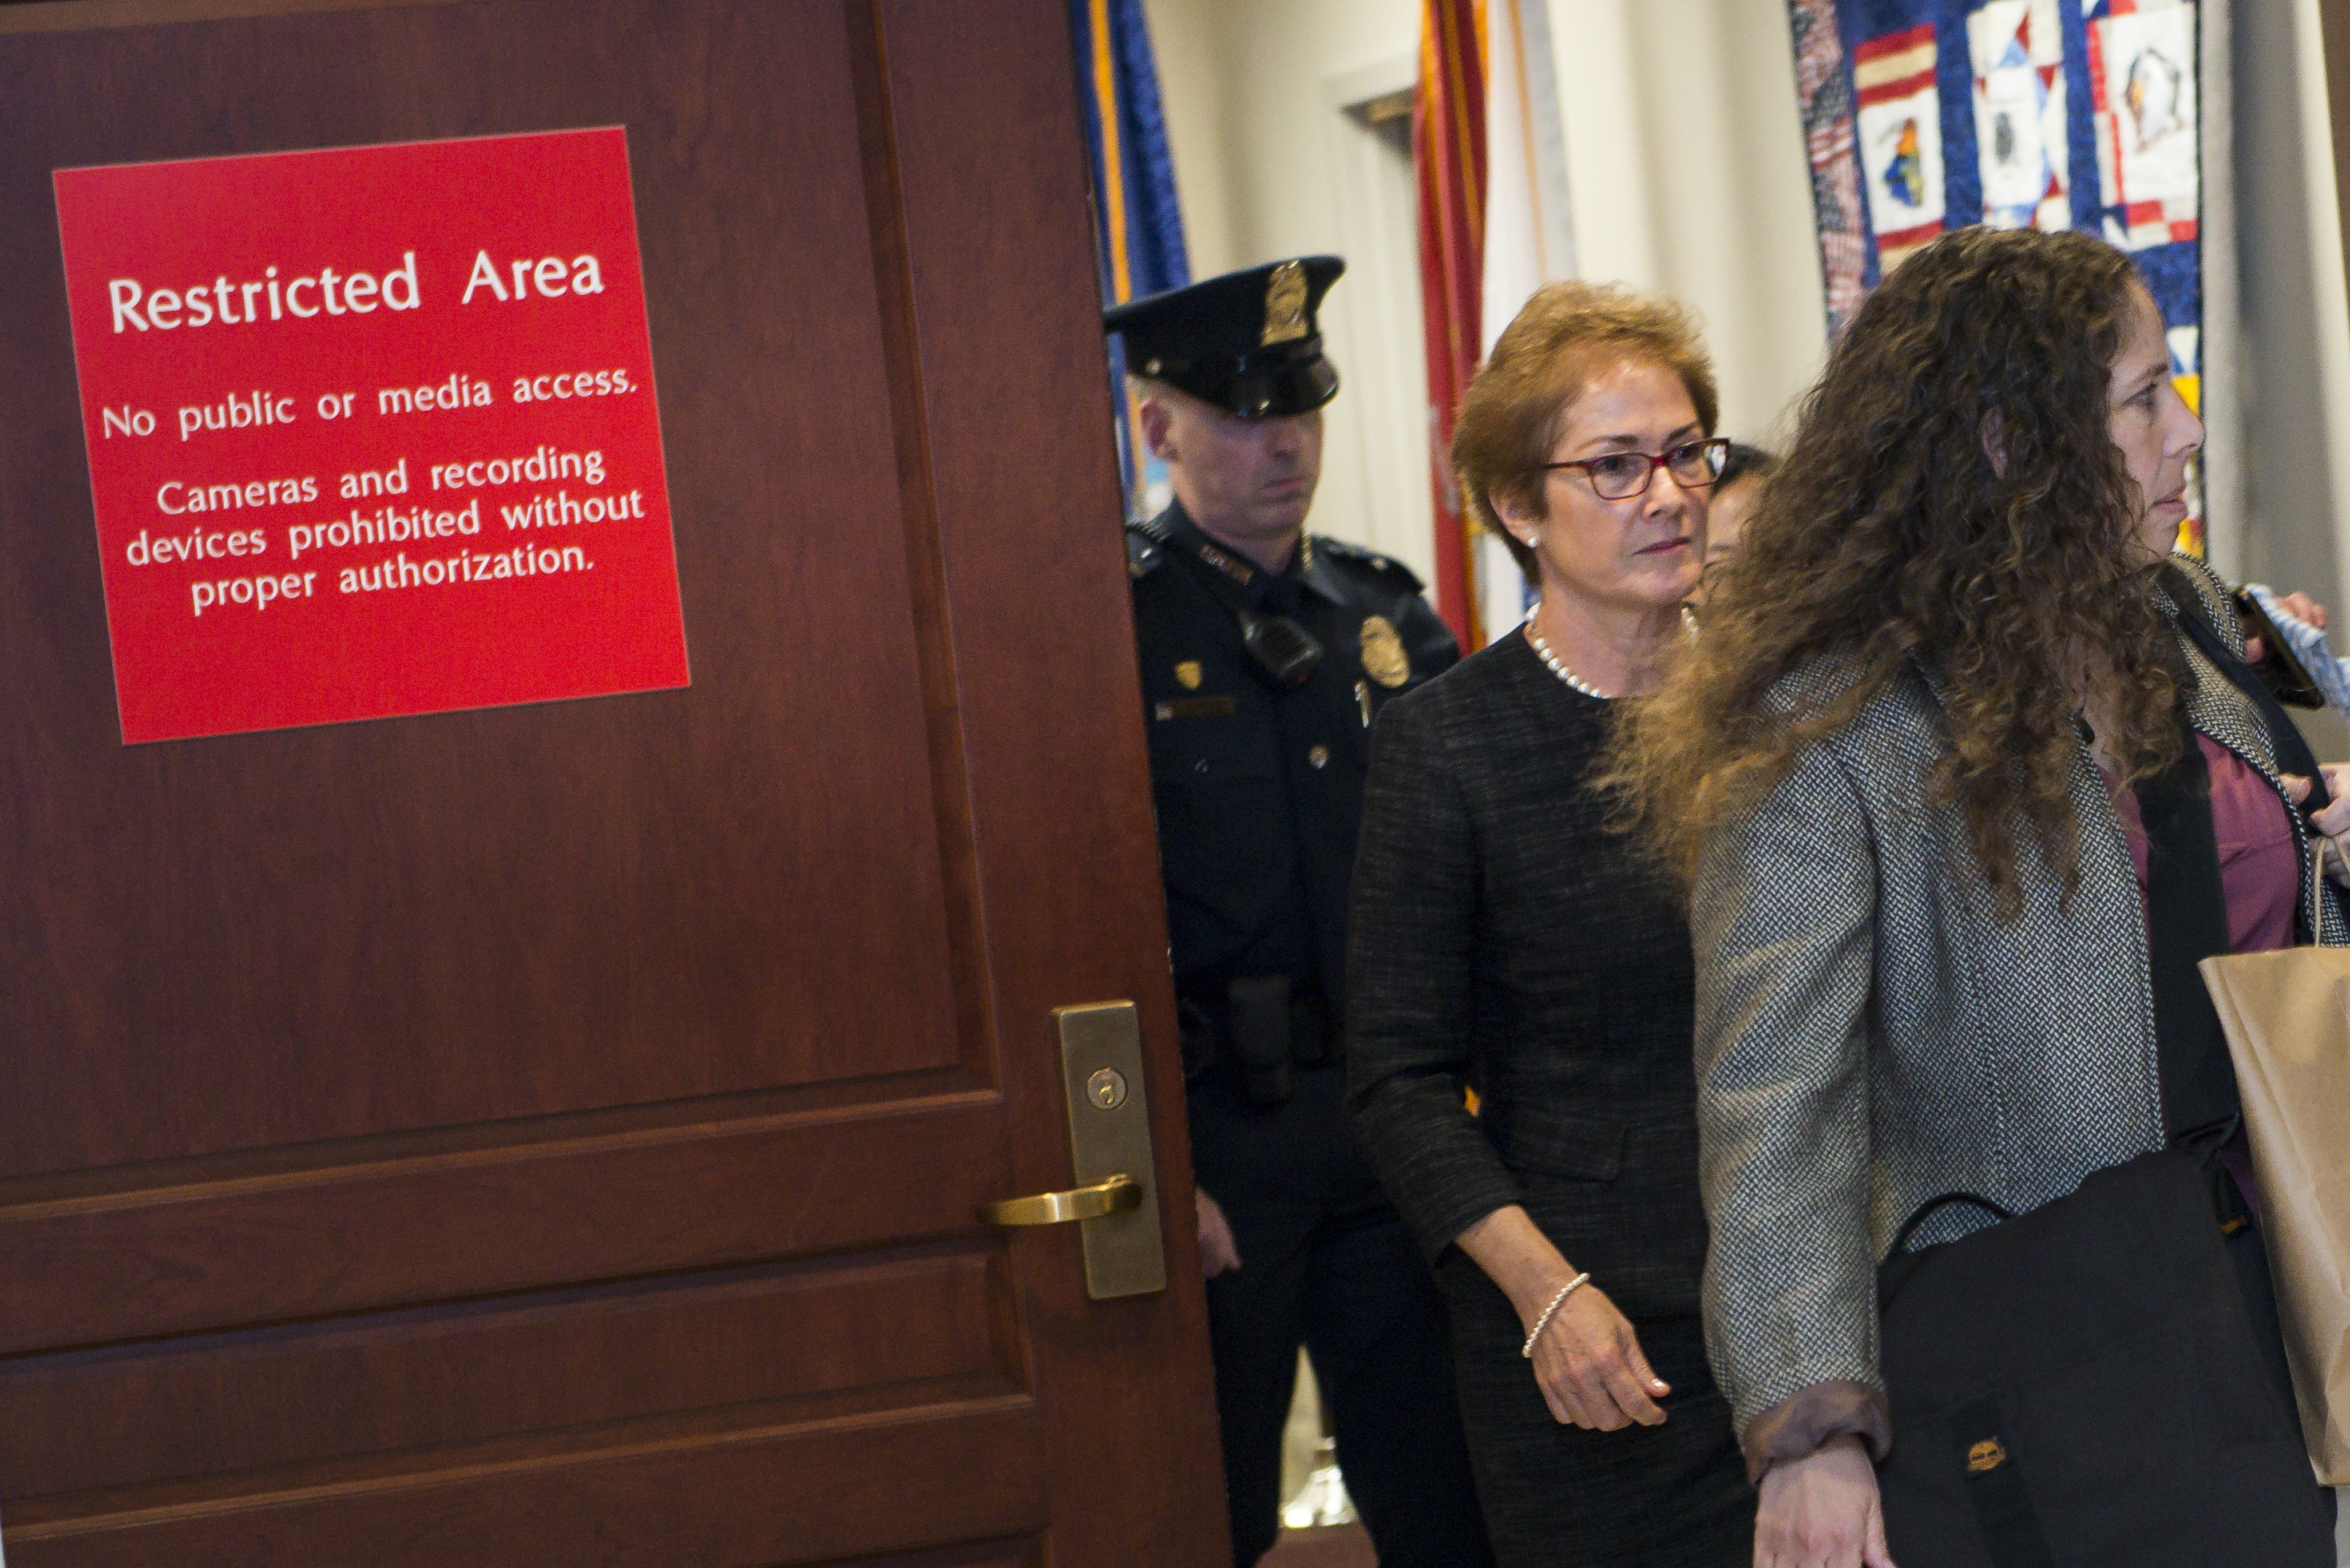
<box><xmin>1617</xmin><ymin>228</ymin><xmax>2350</xmax><ymax>1568</ymax></box>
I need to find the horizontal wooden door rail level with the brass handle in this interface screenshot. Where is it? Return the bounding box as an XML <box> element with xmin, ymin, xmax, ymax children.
<box><xmin>0</xmin><ymin>1095</ymin><xmax>1013</xmax><ymax>1354</ymax></box>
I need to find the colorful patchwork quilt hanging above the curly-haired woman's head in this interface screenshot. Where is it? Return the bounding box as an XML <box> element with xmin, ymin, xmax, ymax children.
<box><xmin>1788</xmin><ymin>0</ymin><xmax>2202</xmax><ymax>555</ymax></box>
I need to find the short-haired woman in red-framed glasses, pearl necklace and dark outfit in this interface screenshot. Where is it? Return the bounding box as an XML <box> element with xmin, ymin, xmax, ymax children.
<box><xmin>1346</xmin><ymin>282</ymin><xmax>1755</xmax><ymax>1568</ymax></box>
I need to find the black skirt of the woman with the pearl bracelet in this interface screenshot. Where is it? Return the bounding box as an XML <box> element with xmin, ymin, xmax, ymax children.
<box><xmin>1441</xmin><ymin>1253</ymin><xmax>1755</xmax><ymax>1568</ymax></box>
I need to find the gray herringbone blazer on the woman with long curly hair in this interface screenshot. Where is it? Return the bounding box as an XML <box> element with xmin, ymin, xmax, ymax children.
<box><xmin>1690</xmin><ymin>562</ymin><xmax>2350</xmax><ymax>1434</ymax></box>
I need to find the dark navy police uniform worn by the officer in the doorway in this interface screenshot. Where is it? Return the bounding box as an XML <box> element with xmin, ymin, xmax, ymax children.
<box><xmin>1128</xmin><ymin>506</ymin><xmax>1490</xmax><ymax>1568</ymax></box>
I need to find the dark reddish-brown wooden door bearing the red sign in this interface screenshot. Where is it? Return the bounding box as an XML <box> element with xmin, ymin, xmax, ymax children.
<box><xmin>0</xmin><ymin>0</ymin><xmax>1224</xmax><ymax>1568</ymax></box>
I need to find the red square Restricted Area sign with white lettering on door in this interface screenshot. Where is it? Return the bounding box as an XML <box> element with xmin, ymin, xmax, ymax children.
<box><xmin>57</xmin><ymin>127</ymin><xmax>686</xmax><ymax>740</ymax></box>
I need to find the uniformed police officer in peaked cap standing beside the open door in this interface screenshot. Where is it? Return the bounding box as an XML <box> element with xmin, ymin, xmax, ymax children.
<box><xmin>1104</xmin><ymin>256</ymin><xmax>1492</xmax><ymax>1568</ymax></box>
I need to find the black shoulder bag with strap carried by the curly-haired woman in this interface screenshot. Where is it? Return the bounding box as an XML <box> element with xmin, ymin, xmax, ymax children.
<box><xmin>1877</xmin><ymin>585</ymin><xmax>2333</xmax><ymax>1568</ymax></box>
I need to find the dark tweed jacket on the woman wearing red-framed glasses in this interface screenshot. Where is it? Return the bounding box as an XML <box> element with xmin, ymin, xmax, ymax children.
<box><xmin>1346</xmin><ymin>632</ymin><xmax>1706</xmax><ymax>1316</ymax></box>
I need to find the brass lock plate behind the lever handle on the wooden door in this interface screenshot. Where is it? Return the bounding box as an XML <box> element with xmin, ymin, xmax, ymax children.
<box><xmin>1053</xmin><ymin>1002</ymin><xmax>1168</xmax><ymax>1300</ymax></box>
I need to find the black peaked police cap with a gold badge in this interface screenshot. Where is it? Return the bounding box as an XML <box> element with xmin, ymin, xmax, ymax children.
<box><xmin>1102</xmin><ymin>256</ymin><xmax>1346</xmax><ymax>418</ymax></box>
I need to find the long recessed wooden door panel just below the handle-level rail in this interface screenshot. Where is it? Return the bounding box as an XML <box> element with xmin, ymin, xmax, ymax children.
<box><xmin>0</xmin><ymin>1237</ymin><xmax>1023</xmax><ymax>1511</ymax></box>
